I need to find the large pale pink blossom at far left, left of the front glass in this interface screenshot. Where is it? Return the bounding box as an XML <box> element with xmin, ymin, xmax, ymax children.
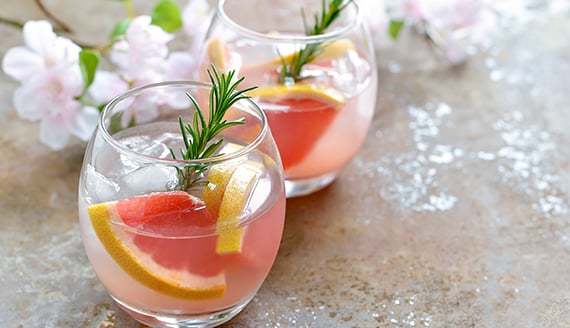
<box><xmin>2</xmin><ymin>21</ymin><xmax>98</xmax><ymax>150</ymax></box>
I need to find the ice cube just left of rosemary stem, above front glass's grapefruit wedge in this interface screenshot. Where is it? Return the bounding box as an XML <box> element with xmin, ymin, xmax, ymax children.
<box><xmin>116</xmin><ymin>165</ymin><xmax>178</xmax><ymax>194</ymax></box>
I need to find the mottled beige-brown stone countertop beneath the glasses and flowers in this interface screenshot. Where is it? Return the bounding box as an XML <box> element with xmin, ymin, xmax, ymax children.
<box><xmin>0</xmin><ymin>0</ymin><xmax>570</xmax><ymax>328</ymax></box>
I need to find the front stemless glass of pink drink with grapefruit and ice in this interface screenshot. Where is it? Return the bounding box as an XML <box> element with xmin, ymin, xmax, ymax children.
<box><xmin>78</xmin><ymin>81</ymin><xmax>285</xmax><ymax>327</ymax></box>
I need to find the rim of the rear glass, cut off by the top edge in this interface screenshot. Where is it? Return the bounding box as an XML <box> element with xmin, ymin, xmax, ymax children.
<box><xmin>216</xmin><ymin>0</ymin><xmax>362</xmax><ymax>43</ymax></box>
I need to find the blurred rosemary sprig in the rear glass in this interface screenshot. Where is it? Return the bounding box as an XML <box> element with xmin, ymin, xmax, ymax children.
<box><xmin>279</xmin><ymin>0</ymin><xmax>354</xmax><ymax>83</ymax></box>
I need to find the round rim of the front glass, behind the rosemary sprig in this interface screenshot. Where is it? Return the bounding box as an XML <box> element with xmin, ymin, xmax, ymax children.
<box><xmin>97</xmin><ymin>81</ymin><xmax>269</xmax><ymax>165</ymax></box>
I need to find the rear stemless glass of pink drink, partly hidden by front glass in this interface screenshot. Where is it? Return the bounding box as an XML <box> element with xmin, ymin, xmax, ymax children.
<box><xmin>200</xmin><ymin>0</ymin><xmax>378</xmax><ymax>197</ymax></box>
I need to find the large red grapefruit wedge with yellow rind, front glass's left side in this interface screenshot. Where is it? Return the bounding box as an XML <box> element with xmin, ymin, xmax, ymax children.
<box><xmin>88</xmin><ymin>191</ymin><xmax>226</xmax><ymax>301</ymax></box>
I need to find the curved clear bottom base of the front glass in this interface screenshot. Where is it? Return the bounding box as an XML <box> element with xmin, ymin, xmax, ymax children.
<box><xmin>111</xmin><ymin>296</ymin><xmax>253</xmax><ymax>328</ymax></box>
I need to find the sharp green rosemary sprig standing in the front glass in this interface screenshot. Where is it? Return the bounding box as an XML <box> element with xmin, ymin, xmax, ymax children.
<box><xmin>170</xmin><ymin>65</ymin><xmax>256</xmax><ymax>191</ymax></box>
